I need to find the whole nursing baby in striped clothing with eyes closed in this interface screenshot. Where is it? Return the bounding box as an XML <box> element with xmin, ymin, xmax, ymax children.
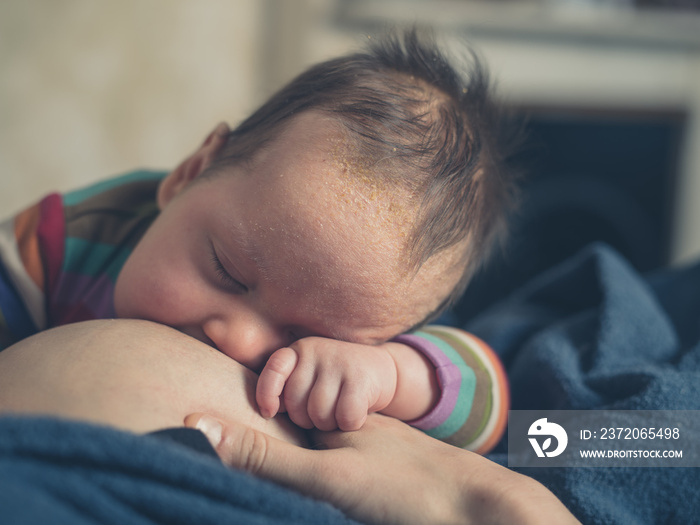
<box><xmin>0</xmin><ymin>31</ymin><xmax>513</xmax><ymax>453</ymax></box>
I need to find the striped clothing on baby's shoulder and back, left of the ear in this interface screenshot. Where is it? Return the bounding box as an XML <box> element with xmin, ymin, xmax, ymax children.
<box><xmin>0</xmin><ymin>171</ymin><xmax>166</xmax><ymax>350</ymax></box>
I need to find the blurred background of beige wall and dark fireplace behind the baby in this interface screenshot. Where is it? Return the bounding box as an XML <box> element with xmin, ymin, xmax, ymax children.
<box><xmin>0</xmin><ymin>0</ymin><xmax>700</xmax><ymax>315</ymax></box>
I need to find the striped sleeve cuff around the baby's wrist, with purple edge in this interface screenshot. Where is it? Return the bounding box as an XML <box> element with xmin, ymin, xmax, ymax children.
<box><xmin>394</xmin><ymin>325</ymin><xmax>510</xmax><ymax>454</ymax></box>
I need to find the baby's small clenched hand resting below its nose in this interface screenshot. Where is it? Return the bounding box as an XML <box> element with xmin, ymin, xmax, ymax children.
<box><xmin>256</xmin><ymin>337</ymin><xmax>397</xmax><ymax>431</ymax></box>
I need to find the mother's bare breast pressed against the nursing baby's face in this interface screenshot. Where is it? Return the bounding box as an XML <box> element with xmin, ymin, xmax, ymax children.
<box><xmin>0</xmin><ymin>320</ymin><xmax>305</xmax><ymax>444</ymax></box>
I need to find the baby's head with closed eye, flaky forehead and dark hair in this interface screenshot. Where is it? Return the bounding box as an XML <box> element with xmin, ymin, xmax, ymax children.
<box><xmin>115</xmin><ymin>28</ymin><xmax>512</xmax><ymax>369</ymax></box>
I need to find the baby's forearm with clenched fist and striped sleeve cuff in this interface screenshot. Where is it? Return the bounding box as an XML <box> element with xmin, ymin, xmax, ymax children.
<box><xmin>256</xmin><ymin>326</ymin><xmax>508</xmax><ymax>452</ymax></box>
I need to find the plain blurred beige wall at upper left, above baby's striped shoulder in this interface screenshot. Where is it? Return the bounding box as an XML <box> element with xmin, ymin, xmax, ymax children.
<box><xmin>0</xmin><ymin>0</ymin><xmax>263</xmax><ymax>217</ymax></box>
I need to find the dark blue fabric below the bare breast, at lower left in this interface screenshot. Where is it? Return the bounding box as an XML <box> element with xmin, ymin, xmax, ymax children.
<box><xmin>0</xmin><ymin>417</ymin><xmax>354</xmax><ymax>525</ymax></box>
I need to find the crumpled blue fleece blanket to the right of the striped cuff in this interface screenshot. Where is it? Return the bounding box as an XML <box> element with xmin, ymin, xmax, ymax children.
<box><xmin>465</xmin><ymin>245</ymin><xmax>700</xmax><ymax>525</ymax></box>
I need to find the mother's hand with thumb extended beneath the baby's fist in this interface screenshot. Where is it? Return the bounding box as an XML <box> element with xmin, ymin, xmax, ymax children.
<box><xmin>185</xmin><ymin>414</ymin><xmax>579</xmax><ymax>525</ymax></box>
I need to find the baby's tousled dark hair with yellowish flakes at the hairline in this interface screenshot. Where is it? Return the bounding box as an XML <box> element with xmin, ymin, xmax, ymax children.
<box><xmin>213</xmin><ymin>29</ymin><xmax>515</xmax><ymax>317</ymax></box>
